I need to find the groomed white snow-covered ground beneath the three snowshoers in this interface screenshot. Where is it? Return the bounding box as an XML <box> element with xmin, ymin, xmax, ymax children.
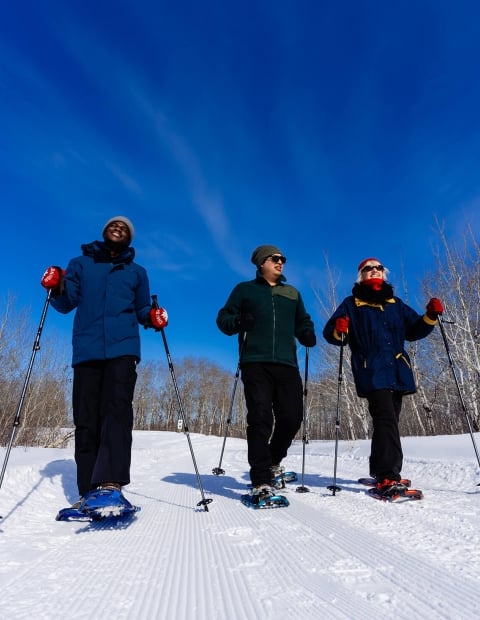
<box><xmin>0</xmin><ymin>432</ymin><xmax>480</xmax><ymax>620</ymax></box>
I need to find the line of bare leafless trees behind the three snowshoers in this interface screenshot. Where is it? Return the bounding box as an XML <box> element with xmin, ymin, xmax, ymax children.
<box><xmin>0</xmin><ymin>222</ymin><xmax>480</xmax><ymax>446</ymax></box>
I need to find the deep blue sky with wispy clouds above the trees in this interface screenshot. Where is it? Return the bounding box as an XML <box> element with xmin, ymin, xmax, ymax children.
<box><xmin>0</xmin><ymin>0</ymin><xmax>480</xmax><ymax>372</ymax></box>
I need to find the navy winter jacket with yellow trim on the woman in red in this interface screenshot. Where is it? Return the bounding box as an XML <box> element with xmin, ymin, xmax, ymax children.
<box><xmin>323</xmin><ymin>289</ymin><xmax>437</xmax><ymax>397</ymax></box>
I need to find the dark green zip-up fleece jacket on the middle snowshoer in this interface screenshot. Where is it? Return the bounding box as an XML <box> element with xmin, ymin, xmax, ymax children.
<box><xmin>217</xmin><ymin>274</ymin><xmax>314</xmax><ymax>367</ymax></box>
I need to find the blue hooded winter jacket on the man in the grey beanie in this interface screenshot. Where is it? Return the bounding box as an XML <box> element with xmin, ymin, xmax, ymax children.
<box><xmin>51</xmin><ymin>241</ymin><xmax>150</xmax><ymax>366</ymax></box>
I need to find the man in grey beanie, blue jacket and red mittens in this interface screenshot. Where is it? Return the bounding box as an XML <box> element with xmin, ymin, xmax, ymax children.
<box><xmin>41</xmin><ymin>216</ymin><xmax>168</xmax><ymax>508</ymax></box>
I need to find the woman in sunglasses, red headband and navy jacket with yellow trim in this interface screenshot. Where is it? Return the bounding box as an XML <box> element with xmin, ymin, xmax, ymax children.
<box><xmin>323</xmin><ymin>258</ymin><xmax>443</xmax><ymax>495</ymax></box>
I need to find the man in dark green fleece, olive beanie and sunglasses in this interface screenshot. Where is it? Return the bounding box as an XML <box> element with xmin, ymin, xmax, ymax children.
<box><xmin>217</xmin><ymin>245</ymin><xmax>317</xmax><ymax>503</ymax></box>
